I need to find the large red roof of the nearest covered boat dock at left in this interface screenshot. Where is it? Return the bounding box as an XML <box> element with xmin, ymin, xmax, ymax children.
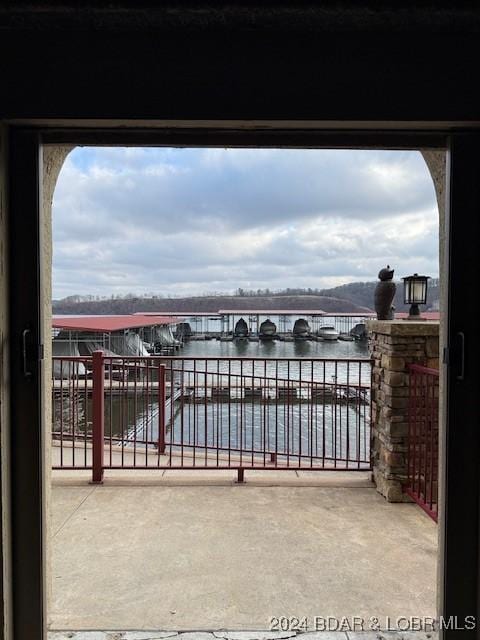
<box><xmin>52</xmin><ymin>315</ymin><xmax>178</xmax><ymax>333</ymax></box>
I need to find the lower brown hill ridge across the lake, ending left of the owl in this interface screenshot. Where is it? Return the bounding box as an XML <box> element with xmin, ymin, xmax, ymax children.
<box><xmin>52</xmin><ymin>295</ymin><xmax>371</xmax><ymax>315</ymax></box>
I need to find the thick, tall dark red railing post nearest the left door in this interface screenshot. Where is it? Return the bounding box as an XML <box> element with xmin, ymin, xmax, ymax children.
<box><xmin>92</xmin><ymin>351</ymin><xmax>105</xmax><ymax>484</ymax></box>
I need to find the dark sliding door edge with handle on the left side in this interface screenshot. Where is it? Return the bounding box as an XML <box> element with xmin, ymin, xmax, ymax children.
<box><xmin>8</xmin><ymin>129</ymin><xmax>46</xmax><ymax>640</ymax></box>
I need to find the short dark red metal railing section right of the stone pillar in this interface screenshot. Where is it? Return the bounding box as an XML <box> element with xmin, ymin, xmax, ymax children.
<box><xmin>404</xmin><ymin>364</ymin><xmax>439</xmax><ymax>521</ymax></box>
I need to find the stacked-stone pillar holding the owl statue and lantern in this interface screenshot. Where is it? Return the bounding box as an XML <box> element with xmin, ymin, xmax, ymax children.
<box><xmin>367</xmin><ymin>320</ymin><xmax>439</xmax><ymax>502</ymax></box>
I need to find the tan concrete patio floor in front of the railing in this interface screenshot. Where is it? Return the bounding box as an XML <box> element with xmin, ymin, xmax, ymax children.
<box><xmin>49</xmin><ymin>471</ymin><xmax>437</xmax><ymax>631</ymax></box>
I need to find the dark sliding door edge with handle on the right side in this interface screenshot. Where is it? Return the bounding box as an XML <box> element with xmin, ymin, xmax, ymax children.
<box><xmin>439</xmin><ymin>131</ymin><xmax>480</xmax><ymax>638</ymax></box>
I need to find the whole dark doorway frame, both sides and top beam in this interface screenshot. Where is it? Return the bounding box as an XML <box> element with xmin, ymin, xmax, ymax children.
<box><xmin>8</xmin><ymin>122</ymin><xmax>480</xmax><ymax>640</ymax></box>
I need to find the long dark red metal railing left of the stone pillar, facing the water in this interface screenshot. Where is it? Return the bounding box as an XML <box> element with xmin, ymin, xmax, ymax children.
<box><xmin>52</xmin><ymin>352</ymin><xmax>371</xmax><ymax>482</ymax></box>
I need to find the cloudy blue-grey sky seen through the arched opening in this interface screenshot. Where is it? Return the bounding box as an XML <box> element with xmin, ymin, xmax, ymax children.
<box><xmin>53</xmin><ymin>147</ymin><xmax>438</xmax><ymax>298</ymax></box>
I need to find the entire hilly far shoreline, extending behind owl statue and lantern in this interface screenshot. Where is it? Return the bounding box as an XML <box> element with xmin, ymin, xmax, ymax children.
<box><xmin>52</xmin><ymin>278</ymin><xmax>439</xmax><ymax>315</ymax></box>
